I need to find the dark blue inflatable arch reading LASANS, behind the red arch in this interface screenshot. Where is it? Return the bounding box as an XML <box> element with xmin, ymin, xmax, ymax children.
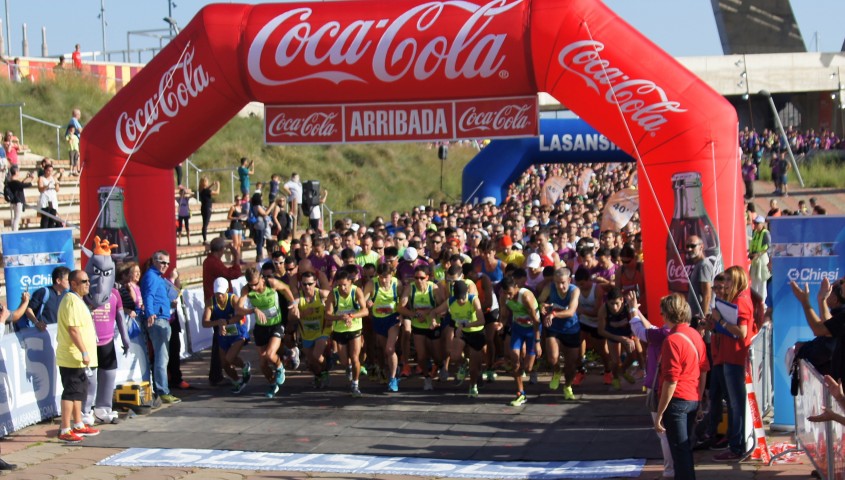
<box><xmin>461</xmin><ymin>118</ymin><xmax>634</xmax><ymax>204</ymax></box>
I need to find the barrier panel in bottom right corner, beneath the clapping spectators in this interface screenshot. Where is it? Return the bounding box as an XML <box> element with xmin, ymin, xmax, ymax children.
<box><xmin>795</xmin><ymin>360</ymin><xmax>845</xmax><ymax>480</ymax></box>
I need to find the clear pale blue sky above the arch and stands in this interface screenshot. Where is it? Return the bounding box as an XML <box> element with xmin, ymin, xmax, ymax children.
<box><xmin>0</xmin><ymin>0</ymin><xmax>845</xmax><ymax>59</ymax></box>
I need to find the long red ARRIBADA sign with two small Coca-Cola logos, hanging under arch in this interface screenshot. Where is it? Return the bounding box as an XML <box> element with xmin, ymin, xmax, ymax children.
<box><xmin>264</xmin><ymin>95</ymin><xmax>539</xmax><ymax>145</ymax></box>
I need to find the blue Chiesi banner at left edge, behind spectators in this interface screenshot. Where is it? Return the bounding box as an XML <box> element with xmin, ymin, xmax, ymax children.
<box><xmin>0</xmin><ymin>228</ymin><xmax>74</xmax><ymax>310</ymax></box>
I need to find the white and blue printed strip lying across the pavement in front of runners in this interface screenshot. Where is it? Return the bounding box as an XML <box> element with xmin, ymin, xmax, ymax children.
<box><xmin>97</xmin><ymin>448</ymin><xmax>645</xmax><ymax>480</ymax></box>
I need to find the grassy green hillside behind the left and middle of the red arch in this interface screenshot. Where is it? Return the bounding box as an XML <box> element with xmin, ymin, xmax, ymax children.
<box><xmin>0</xmin><ymin>74</ymin><xmax>476</xmax><ymax>219</ymax></box>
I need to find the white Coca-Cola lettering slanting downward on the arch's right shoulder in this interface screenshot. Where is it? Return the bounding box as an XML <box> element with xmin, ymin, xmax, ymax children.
<box><xmin>558</xmin><ymin>40</ymin><xmax>686</xmax><ymax>132</ymax></box>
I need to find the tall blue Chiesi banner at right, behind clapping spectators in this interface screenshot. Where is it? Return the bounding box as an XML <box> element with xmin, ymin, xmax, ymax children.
<box><xmin>769</xmin><ymin>216</ymin><xmax>845</xmax><ymax>428</ymax></box>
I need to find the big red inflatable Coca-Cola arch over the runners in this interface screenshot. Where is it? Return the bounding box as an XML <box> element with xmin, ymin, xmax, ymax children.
<box><xmin>81</xmin><ymin>0</ymin><xmax>746</xmax><ymax>311</ymax></box>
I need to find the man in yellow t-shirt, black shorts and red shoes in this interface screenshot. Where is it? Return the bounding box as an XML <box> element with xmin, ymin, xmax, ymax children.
<box><xmin>56</xmin><ymin>270</ymin><xmax>100</xmax><ymax>443</ymax></box>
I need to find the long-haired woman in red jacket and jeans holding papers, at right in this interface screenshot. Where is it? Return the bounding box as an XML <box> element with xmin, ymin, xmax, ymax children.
<box><xmin>710</xmin><ymin>265</ymin><xmax>755</xmax><ymax>462</ymax></box>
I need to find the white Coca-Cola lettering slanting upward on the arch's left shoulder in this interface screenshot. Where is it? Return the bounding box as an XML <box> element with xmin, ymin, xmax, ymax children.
<box><xmin>115</xmin><ymin>44</ymin><xmax>212</xmax><ymax>155</ymax></box>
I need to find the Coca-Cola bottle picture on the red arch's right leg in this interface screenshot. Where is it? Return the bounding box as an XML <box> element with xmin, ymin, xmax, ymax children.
<box><xmin>666</xmin><ymin>172</ymin><xmax>722</xmax><ymax>294</ymax></box>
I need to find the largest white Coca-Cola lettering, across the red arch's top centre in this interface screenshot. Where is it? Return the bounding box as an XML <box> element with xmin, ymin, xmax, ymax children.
<box><xmin>247</xmin><ymin>0</ymin><xmax>522</xmax><ymax>86</ymax></box>
